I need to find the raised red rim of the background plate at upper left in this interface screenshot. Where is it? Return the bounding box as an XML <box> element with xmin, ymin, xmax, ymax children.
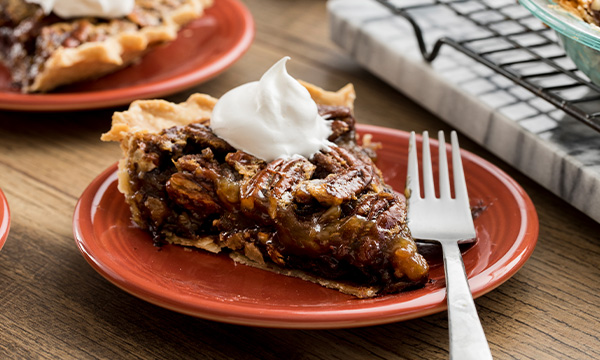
<box><xmin>0</xmin><ymin>0</ymin><xmax>255</xmax><ymax>111</ymax></box>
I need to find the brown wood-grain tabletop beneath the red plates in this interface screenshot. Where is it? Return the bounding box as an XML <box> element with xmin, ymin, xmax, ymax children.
<box><xmin>0</xmin><ymin>0</ymin><xmax>600</xmax><ymax>359</ymax></box>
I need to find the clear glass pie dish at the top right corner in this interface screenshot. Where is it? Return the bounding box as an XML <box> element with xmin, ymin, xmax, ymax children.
<box><xmin>519</xmin><ymin>0</ymin><xmax>600</xmax><ymax>85</ymax></box>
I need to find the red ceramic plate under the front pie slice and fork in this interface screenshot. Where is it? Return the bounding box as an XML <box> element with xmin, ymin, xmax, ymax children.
<box><xmin>73</xmin><ymin>125</ymin><xmax>538</xmax><ymax>328</ymax></box>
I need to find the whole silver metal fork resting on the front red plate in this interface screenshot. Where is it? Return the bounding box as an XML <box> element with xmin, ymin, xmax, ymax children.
<box><xmin>406</xmin><ymin>131</ymin><xmax>492</xmax><ymax>360</ymax></box>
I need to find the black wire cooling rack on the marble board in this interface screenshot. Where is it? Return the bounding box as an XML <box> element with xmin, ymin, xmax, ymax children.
<box><xmin>375</xmin><ymin>0</ymin><xmax>600</xmax><ymax>132</ymax></box>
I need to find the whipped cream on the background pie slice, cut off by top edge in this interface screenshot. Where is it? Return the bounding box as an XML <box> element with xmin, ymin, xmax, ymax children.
<box><xmin>25</xmin><ymin>0</ymin><xmax>135</xmax><ymax>19</ymax></box>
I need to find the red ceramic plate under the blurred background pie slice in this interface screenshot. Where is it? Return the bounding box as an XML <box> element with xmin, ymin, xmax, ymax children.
<box><xmin>0</xmin><ymin>0</ymin><xmax>254</xmax><ymax>111</ymax></box>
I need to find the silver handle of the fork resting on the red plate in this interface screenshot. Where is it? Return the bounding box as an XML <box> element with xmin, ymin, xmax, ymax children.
<box><xmin>442</xmin><ymin>241</ymin><xmax>492</xmax><ymax>360</ymax></box>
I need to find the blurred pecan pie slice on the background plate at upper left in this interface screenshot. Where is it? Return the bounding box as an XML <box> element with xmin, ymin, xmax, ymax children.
<box><xmin>0</xmin><ymin>0</ymin><xmax>212</xmax><ymax>92</ymax></box>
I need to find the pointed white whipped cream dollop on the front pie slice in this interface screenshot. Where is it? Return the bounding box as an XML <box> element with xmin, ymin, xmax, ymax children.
<box><xmin>210</xmin><ymin>57</ymin><xmax>333</xmax><ymax>161</ymax></box>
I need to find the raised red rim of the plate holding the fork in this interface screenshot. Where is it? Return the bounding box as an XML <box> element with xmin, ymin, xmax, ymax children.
<box><xmin>73</xmin><ymin>125</ymin><xmax>539</xmax><ymax>329</ymax></box>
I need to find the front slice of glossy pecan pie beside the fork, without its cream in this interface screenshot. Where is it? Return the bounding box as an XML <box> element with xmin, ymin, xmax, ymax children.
<box><xmin>102</xmin><ymin>83</ymin><xmax>428</xmax><ymax>298</ymax></box>
